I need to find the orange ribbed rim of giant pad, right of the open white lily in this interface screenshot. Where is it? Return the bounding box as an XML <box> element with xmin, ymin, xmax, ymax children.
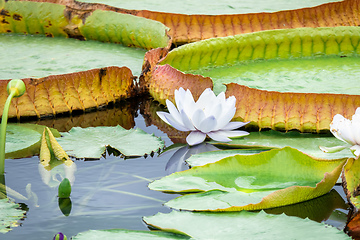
<box><xmin>226</xmin><ymin>83</ymin><xmax>360</xmax><ymax>133</ymax></box>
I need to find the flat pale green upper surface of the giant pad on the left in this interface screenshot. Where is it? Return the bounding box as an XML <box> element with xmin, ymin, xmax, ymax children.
<box><xmin>0</xmin><ymin>34</ymin><xmax>146</xmax><ymax>79</ymax></box>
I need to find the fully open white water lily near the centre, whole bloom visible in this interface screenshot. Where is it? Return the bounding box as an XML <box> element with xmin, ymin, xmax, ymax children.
<box><xmin>157</xmin><ymin>88</ymin><xmax>249</xmax><ymax>145</ymax></box>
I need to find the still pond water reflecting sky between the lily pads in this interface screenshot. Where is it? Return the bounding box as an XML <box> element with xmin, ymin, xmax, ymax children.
<box><xmin>1</xmin><ymin>98</ymin><xmax>347</xmax><ymax>240</ymax></box>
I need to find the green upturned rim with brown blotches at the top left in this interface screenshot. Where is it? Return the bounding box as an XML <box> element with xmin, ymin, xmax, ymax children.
<box><xmin>0</xmin><ymin>0</ymin><xmax>171</xmax><ymax>49</ymax></box>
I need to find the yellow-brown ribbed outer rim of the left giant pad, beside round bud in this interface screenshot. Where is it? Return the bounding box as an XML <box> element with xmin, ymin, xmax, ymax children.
<box><xmin>0</xmin><ymin>67</ymin><xmax>135</xmax><ymax>118</ymax></box>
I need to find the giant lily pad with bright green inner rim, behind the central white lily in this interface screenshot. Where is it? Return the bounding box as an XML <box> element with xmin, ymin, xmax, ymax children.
<box><xmin>143</xmin><ymin>27</ymin><xmax>360</xmax><ymax>132</ymax></box>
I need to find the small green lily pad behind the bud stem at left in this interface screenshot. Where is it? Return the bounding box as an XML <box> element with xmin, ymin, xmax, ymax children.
<box><xmin>5</xmin><ymin>124</ymin><xmax>60</xmax><ymax>158</ymax></box>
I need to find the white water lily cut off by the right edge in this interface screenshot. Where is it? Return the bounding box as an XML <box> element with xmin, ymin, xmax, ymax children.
<box><xmin>320</xmin><ymin>107</ymin><xmax>360</xmax><ymax>158</ymax></box>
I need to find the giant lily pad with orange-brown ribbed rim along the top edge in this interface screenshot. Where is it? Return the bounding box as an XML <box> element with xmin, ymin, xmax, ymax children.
<box><xmin>74</xmin><ymin>0</ymin><xmax>357</xmax><ymax>44</ymax></box>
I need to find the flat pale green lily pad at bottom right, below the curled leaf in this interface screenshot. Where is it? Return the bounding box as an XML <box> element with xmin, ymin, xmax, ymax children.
<box><xmin>144</xmin><ymin>211</ymin><xmax>351</xmax><ymax>239</ymax></box>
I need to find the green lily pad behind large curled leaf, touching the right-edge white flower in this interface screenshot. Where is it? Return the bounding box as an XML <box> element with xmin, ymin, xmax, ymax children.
<box><xmin>211</xmin><ymin>130</ymin><xmax>354</xmax><ymax>160</ymax></box>
